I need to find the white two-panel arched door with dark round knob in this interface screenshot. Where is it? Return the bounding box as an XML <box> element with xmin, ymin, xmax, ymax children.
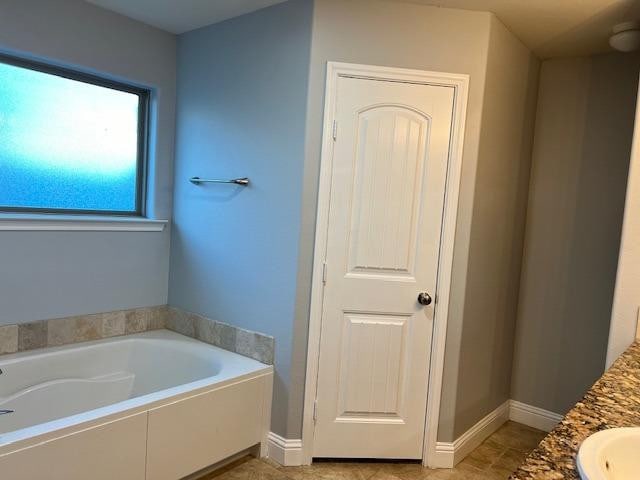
<box><xmin>313</xmin><ymin>77</ymin><xmax>454</xmax><ymax>459</ymax></box>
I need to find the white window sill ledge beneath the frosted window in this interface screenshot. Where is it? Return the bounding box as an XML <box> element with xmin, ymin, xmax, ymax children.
<box><xmin>0</xmin><ymin>213</ymin><xmax>168</xmax><ymax>232</ymax></box>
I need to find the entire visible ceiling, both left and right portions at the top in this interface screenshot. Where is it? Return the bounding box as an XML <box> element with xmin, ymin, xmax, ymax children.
<box><xmin>87</xmin><ymin>0</ymin><xmax>640</xmax><ymax>58</ymax></box>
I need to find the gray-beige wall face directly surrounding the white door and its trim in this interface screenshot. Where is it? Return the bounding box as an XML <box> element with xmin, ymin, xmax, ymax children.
<box><xmin>298</xmin><ymin>0</ymin><xmax>491</xmax><ymax>441</ymax></box>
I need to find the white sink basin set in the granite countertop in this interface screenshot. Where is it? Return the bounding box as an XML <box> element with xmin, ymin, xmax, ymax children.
<box><xmin>578</xmin><ymin>428</ymin><xmax>640</xmax><ymax>480</ymax></box>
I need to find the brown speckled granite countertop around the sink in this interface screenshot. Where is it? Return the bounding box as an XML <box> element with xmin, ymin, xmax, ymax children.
<box><xmin>509</xmin><ymin>341</ymin><xmax>640</xmax><ymax>480</ymax></box>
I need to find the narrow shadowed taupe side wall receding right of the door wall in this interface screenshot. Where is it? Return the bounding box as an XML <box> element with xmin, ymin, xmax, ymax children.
<box><xmin>450</xmin><ymin>17</ymin><xmax>540</xmax><ymax>440</ymax></box>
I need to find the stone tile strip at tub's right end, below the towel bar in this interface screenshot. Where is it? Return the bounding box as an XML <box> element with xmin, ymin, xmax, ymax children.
<box><xmin>165</xmin><ymin>307</ymin><xmax>275</xmax><ymax>365</ymax></box>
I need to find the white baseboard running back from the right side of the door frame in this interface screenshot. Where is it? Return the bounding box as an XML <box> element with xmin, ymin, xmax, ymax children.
<box><xmin>429</xmin><ymin>400</ymin><xmax>510</xmax><ymax>468</ymax></box>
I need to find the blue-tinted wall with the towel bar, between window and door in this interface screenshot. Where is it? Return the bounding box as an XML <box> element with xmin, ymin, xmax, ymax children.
<box><xmin>169</xmin><ymin>0</ymin><xmax>313</xmax><ymax>435</ymax></box>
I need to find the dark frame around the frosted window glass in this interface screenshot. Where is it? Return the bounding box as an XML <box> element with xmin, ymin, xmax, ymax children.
<box><xmin>0</xmin><ymin>53</ymin><xmax>151</xmax><ymax>218</ymax></box>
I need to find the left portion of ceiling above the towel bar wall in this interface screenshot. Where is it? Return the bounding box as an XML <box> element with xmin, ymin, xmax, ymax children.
<box><xmin>86</xmin><ymin>0</ymin><xmax>285</xmax><ymax>34</ymax></box>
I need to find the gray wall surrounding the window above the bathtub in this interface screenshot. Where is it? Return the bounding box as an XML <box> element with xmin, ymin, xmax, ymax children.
<box><xmin>0</xmin><ymin>0</ymin><xmax>175</xmax><ymax>324</ymax></box>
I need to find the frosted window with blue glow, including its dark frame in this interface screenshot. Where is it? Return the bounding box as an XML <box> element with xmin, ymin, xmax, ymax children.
<box><xmin>0</xmin><ymin>56</ymin><xmax>149</xmax><ymax>216</ymax></box>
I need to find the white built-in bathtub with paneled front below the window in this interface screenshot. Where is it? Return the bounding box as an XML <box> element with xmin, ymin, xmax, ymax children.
<box><xmin>0</xmin><ymin>330</ymin><xmax>273</xmax><ymax>480</ymax></box>
